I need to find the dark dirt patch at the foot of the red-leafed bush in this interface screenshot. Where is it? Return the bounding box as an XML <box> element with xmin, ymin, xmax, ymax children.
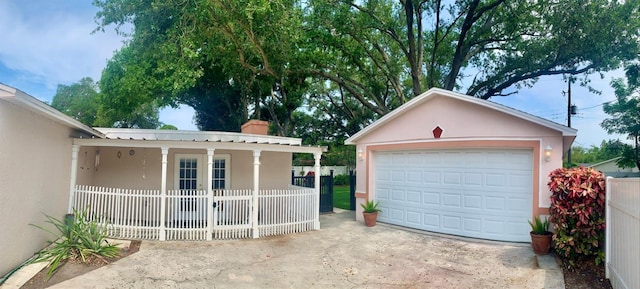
<box><xmin>562</xmin><ymin>254</ymin><xmax>613</xmax><ymax>289</ymax></box>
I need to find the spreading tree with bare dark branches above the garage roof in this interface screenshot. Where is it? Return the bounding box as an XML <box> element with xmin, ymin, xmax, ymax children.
<box><xmin>307</xmin><ymin>0</ymin><xmax>639</xmax><ymax>116</ymax></box>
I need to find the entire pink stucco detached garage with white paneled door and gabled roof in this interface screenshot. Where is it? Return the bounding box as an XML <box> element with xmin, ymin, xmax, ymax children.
<box><xmin>345</xmin><ymin>89</ymin><xmax>576</xmax><ymax>242</ymax></box>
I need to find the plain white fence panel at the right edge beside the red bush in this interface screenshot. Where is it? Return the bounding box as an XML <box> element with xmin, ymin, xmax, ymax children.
<box><xmin>606</xmin><ymin>177</ymin><xmax>640</xmax><ymax>289</ymax></box>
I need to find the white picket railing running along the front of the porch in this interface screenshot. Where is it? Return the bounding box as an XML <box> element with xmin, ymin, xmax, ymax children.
<box><xmin>73</xmin><ymin>186</ymin><xmax>318</xmax><ymax>241</ymax></box>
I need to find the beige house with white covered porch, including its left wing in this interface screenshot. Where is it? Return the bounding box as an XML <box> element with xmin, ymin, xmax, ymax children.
<box><xmin>0</xmin><ymin>84</ymin><xmax>325</xmax><ymax>275</ymax></box>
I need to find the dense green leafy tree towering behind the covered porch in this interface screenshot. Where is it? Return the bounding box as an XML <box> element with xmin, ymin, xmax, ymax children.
<box><xmin>94</xmin><ymin>0</ymin><xmax>306</xmax><ymax>135</ymax></box>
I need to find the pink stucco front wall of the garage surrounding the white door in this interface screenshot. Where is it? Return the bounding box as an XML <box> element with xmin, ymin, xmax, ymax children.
<box><xmin>356</xmin><ymin>97</ymin><xmax>563</xmax><ymax>220</ymax></box>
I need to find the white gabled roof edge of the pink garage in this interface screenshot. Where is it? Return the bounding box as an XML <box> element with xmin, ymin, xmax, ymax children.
<box><xmin>345</xmin><ymin>88</ymin><xmax>578</xmax><ymax>145</ymax></box>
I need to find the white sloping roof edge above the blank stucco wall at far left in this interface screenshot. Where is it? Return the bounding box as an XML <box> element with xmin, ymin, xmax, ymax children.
<box><xmin>0</xmin><ymin>83</ymin><xmax>103</xmax><ymax>137</ymax></box>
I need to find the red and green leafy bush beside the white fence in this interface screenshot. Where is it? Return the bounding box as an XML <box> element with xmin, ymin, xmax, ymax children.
<box><xmin>548</xmin><ymin>167</ymin><xmax>606</xmax><ymax>264</ymax></box>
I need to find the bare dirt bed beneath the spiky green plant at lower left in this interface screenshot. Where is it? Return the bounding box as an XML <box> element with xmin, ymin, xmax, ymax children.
<box><xmin>20</xmin><ymin>241</ymin><xmax>141</xmax><ymax>289</ymax></box>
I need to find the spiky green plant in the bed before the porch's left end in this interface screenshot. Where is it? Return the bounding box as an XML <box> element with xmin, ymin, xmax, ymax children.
<box><xmin>32</xmin><ymin>209</ymin><xmax>120</xmax><ymax>278</ymax></box>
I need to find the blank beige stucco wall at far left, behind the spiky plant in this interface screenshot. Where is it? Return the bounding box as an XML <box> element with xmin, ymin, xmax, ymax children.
<box><xmin>0</xmin><ymin>99</ymin><xmax>72</xmax><ymax>276</ymax></box>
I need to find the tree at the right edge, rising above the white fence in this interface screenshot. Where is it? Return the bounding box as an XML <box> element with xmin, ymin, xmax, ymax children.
<box><xmin>600</xmin><ymin>62</ymin><xmax>640</xmax><ymax>170</ymax></box>
